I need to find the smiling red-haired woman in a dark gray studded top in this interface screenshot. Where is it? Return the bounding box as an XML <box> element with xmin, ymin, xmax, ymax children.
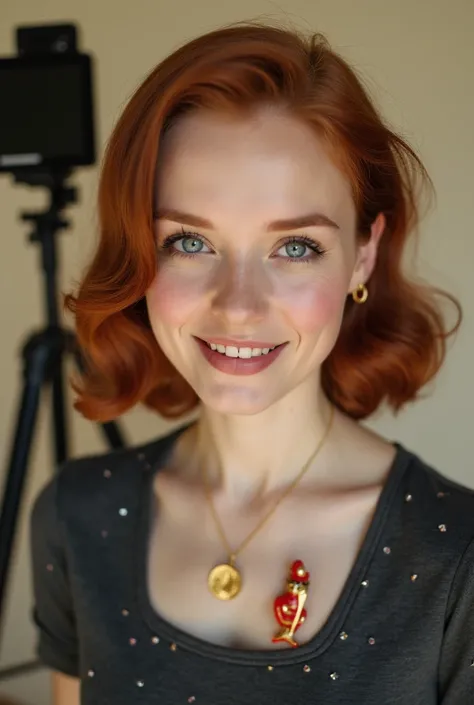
<box><xmin>32</xmin><ymin>24</ymin><xmax>474</xmax><ymax>705</ymax></box>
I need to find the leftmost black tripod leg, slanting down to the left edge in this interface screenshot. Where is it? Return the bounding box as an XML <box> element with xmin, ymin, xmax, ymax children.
<box><xmin>0</xmin><ymin>350</ymin><xmax>47</xmax><ymax>640</ymax></box>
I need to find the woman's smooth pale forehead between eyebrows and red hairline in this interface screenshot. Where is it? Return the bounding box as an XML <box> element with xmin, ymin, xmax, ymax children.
<box><xmin>156</xmin><ymin>110</ymin><xmax>354</xmax><ymax>222</ymax></box>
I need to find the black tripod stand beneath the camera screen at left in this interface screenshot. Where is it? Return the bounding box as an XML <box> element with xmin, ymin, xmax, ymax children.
<box><xmin>0</xmin><ymin>170</ymin><xmax>124</xmax><ymax>677</ymax></box>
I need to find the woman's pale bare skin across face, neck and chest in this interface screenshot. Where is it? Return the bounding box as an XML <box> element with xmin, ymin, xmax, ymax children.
<box><xmin>51</xmin><ymin>109</ymin><xmax>395</xmax><ymax>705</ymax></box>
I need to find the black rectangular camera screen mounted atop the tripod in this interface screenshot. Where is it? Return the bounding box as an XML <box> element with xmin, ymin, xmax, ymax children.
<box><xmin>0</xmin><ymin>55</ymin><xmax>94</xmax><ymax>170</ymax></box>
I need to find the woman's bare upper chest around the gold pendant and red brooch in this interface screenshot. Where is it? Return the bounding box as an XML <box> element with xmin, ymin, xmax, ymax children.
<box><xmin>147</xmin><ymin>478</ymin><xmax>380</xmax><ymax>649</ymax></box>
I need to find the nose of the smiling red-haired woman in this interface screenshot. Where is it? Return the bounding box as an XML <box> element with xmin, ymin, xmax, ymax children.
<box><xmin>212</xmin><ymin>260</ymin><xmax>271</xmax><ymax>325</ymax></box>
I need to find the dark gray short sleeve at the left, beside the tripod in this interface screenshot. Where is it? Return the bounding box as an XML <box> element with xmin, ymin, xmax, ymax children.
<box><xmin>30</xmin><ymin>475</ymin><xmax>79</xmax><ymax>676</ymax></box>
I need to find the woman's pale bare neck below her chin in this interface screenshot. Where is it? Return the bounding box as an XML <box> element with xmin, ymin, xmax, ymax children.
<box><xmin>188</xmin><ymin>384</ymin><xmax>331</xmax><ymax>503</ymax></box>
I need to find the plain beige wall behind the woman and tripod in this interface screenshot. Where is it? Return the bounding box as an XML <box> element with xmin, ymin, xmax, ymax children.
<box><xmin>0</xmin><ymin>0</ymin><xmax>474</xmax><ymax>705</ymax></box>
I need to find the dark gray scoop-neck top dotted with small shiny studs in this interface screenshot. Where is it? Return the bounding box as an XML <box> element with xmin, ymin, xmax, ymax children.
<box><xmin>31</xmin><ymin>426</ymin><xmax>474</xmax><ymax>705</ymax></box>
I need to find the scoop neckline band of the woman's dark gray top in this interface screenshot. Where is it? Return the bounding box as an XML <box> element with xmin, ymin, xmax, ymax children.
<box><xmin>133</xmin><ymin>422</ymin><xmax>411</xmax><ymax>666</ymax></box>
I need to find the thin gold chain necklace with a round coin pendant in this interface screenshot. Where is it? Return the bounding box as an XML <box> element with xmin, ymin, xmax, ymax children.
<box><xmin>202</xmin><ymin>405</ymin><xmax>334</xmax><ymax>600</ymax></box>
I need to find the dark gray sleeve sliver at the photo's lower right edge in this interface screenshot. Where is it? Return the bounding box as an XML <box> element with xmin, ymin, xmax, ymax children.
<box><xmin>439</xmin><ymin>539</ymin><xmax>474</xmax><ymax>705</ymax></box>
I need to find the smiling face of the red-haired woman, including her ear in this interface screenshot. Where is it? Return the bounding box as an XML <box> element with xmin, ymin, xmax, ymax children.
<box><xmin>147</xmin><ymin>110</ymin><xmax>383</xmax><ymax>414</ymax></box>
